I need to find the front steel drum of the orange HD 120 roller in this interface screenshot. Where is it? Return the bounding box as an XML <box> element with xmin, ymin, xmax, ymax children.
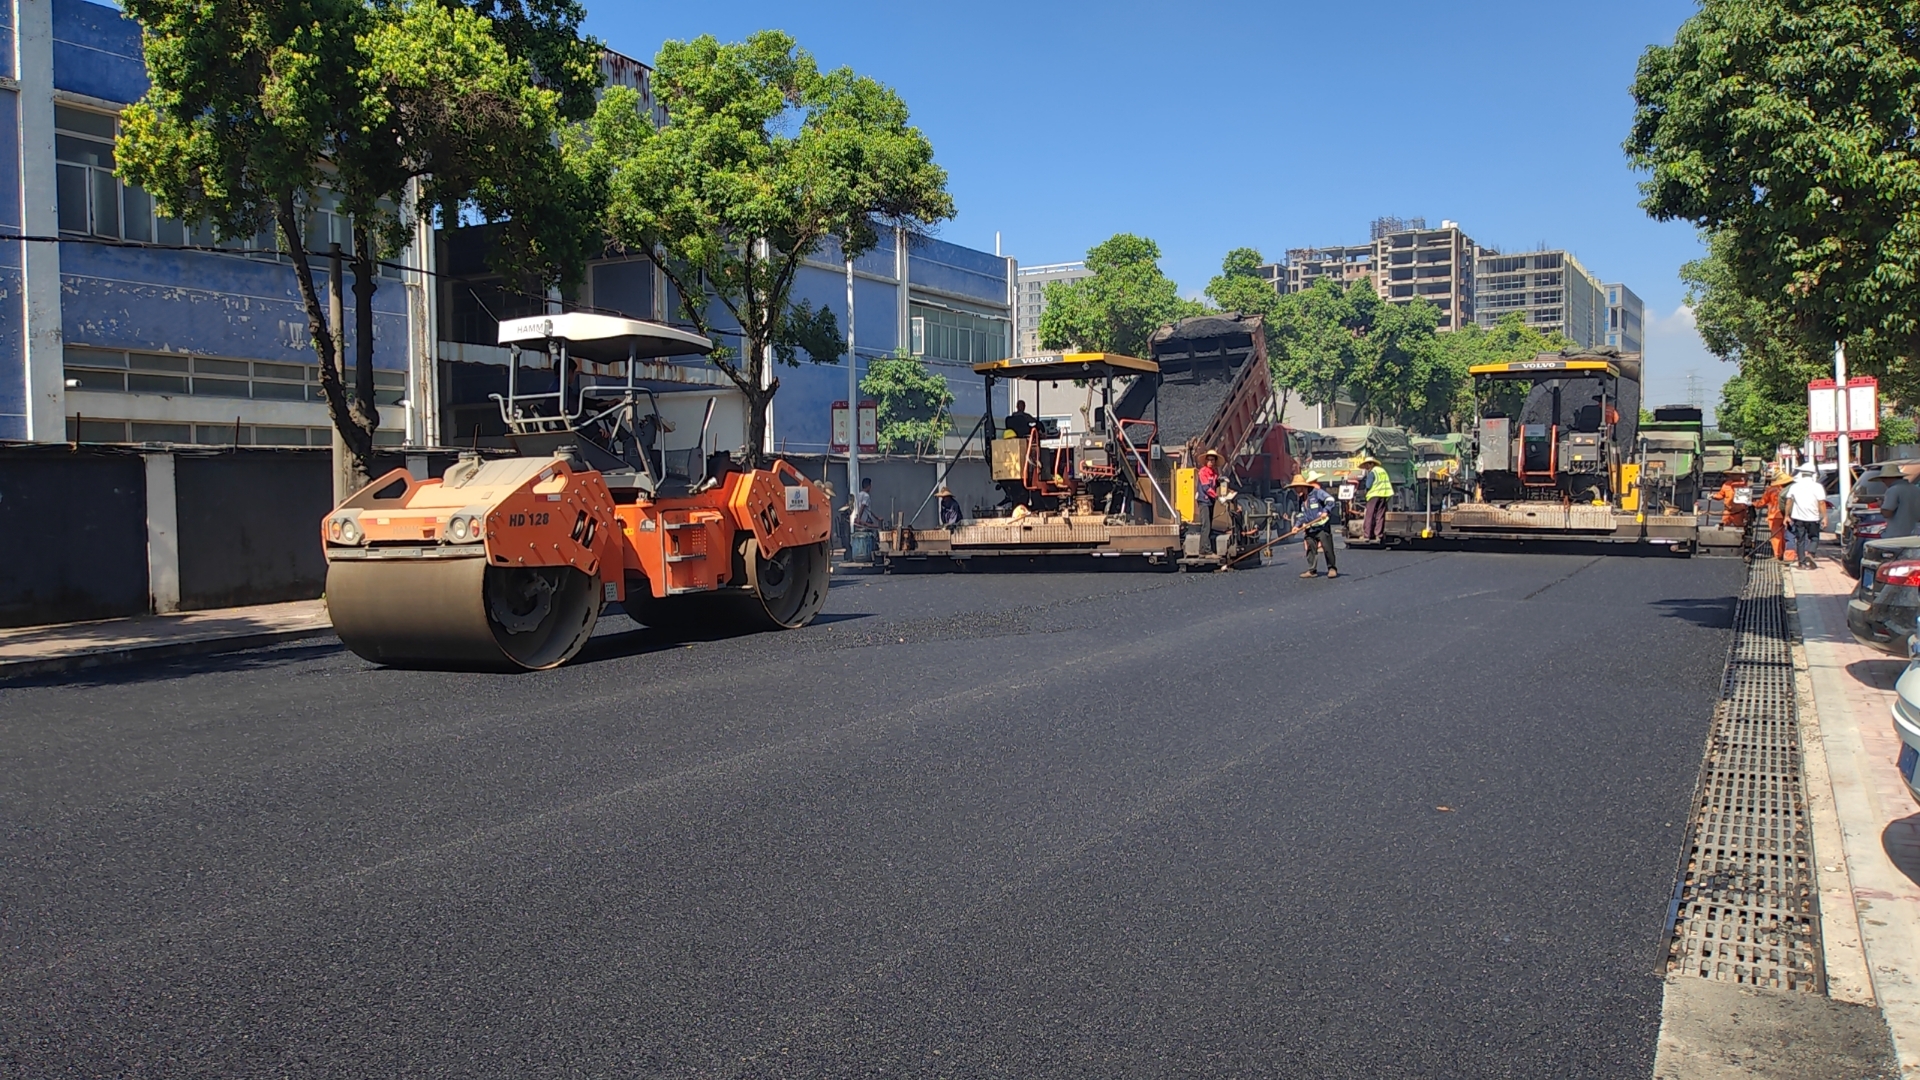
<box><xmin>326</xmin><ymin>559</ymin><xmax>599</xmax><ymax>671</ymax></box>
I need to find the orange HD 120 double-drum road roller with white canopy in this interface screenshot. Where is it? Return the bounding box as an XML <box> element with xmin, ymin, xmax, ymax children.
<box><xmin>321</xmin><ymin>313</ymin><xmax>831</xmax><ymax>671</ymax></box>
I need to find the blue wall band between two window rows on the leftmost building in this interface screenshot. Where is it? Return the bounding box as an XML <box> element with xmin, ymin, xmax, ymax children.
<box><xmin>60</xmin><ymin>244</ymin><xmax>407</xmax><ymax>371</ymax></box>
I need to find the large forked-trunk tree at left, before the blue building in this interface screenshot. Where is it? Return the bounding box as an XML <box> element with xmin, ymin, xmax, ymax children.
<box><xmin>115</xmin><ymin>0</ymin><xmax>578</xmax><ymax>479</ymax></box>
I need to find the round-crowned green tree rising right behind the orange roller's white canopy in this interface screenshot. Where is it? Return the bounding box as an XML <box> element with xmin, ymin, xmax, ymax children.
<box><xmin>584</xmin><ymin>31</ymin><xmax>954</xmax><ymax>461</ymax></box>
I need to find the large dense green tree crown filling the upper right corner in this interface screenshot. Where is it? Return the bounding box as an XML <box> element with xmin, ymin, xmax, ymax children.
<box><xmin>1626</xmin><ymin>0</ymin><xmax>1920</xmax><ymax>384</ymax></box>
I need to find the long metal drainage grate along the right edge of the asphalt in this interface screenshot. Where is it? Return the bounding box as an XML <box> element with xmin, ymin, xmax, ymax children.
<box><xmin>1667</xmin><ymin>559</ymin><xmax>1826</xmax><ymax>992</ymax></box>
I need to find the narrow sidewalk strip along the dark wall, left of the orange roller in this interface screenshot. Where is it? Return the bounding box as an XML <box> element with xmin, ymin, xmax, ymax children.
<box><xmin>0</xmin><ymin>600</ymin><xmax>334</xmax><ymax>678</ymax></box>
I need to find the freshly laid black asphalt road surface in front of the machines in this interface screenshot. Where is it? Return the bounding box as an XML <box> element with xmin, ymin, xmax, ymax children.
<box><xmin>0</xmin><ymin>548</ymin><xmax>1743</xmax><ymax>1078</ymax></box>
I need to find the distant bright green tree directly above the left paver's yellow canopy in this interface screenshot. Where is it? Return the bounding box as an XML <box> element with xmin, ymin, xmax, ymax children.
<box><xmin>1039</xmin><ymin>233</ymin><xmax>1206</xmax><ymax>357</ymax></box>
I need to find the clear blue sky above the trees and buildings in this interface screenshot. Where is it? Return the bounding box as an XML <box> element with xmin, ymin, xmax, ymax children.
<box><xmin>588</xmin><ymin>0</ymin><xmax>1732</xmax><ymax>407</ymax></box>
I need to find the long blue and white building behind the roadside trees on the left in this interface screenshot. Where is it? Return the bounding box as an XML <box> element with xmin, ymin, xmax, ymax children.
<box><xmin>0</xmin><ymin>0</ymin><xmax>1018</xmax><ymax>454</ymax></box>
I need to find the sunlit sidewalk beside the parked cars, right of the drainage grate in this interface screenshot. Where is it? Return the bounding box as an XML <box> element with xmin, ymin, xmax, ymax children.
<box><xmin>1788</xmin><ymin>552</ymin><xmax>1920</xmax><ymax>1078</ymax></box>
